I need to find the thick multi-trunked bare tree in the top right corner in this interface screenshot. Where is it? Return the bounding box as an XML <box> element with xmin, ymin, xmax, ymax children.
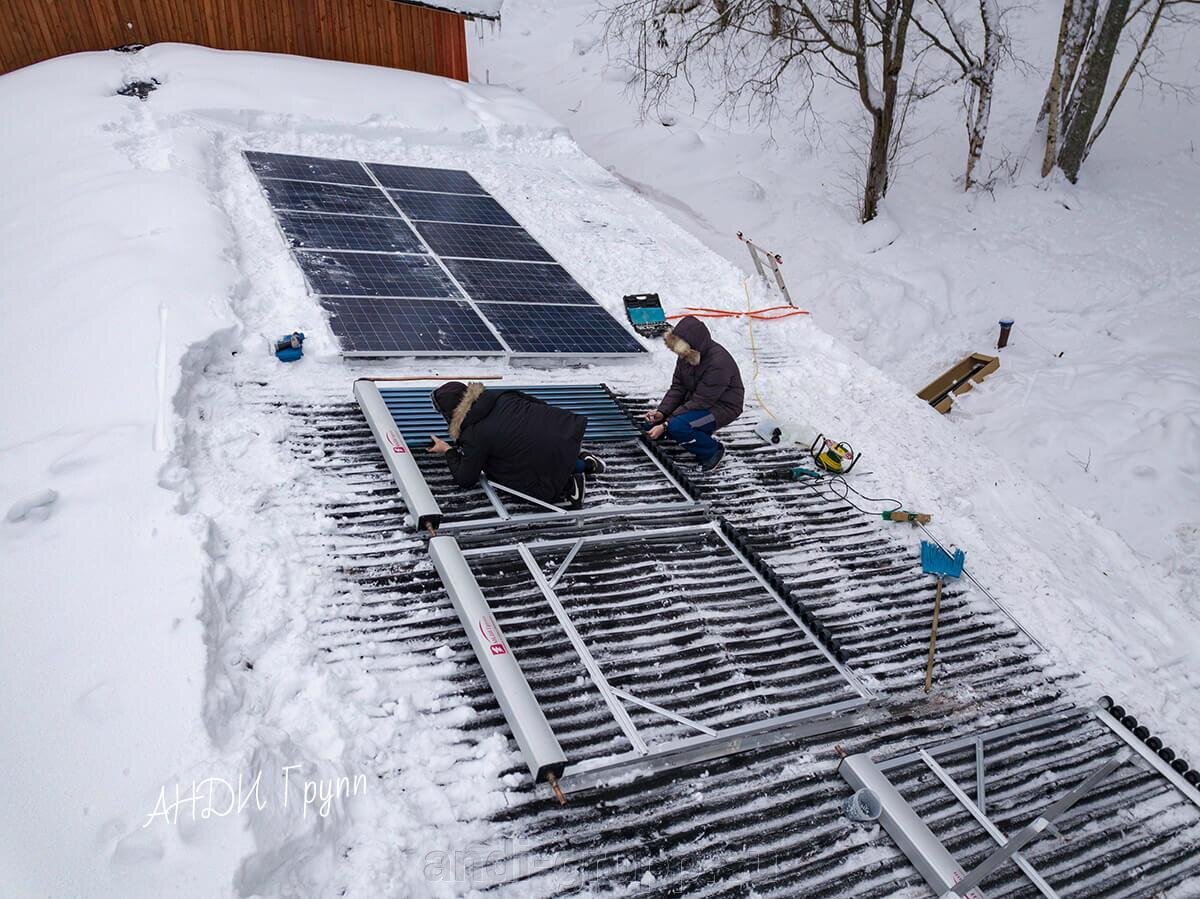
<box><xmin>1038</xmin><ymin>0</ymin><xmax>1200</xmax><ymax>181</ymax></box>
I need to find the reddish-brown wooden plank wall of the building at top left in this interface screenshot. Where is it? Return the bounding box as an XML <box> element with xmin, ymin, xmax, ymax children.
<box><xmin>0</xmin><ymin>0</ymin><xmax>467</xmax><ymax>80</ymax></box>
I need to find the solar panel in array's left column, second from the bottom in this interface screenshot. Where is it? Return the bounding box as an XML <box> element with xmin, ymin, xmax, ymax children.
<box><xmin>296</xmin><ymin>250</ymin><xmax>462</xmax><ymax>299</ymax></box>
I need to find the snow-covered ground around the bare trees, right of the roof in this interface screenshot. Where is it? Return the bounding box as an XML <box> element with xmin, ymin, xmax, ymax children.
<box><xmin>470</xmin><ymin>0</ymin><xmax>1200</xmax><ymax>600</ymax></box>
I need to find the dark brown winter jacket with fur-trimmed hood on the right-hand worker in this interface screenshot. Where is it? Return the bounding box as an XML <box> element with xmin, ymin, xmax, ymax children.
<box><xmin>659</xmin><ymin>316</ymin><xmax>745</xmax><ymax>427</ymax></box>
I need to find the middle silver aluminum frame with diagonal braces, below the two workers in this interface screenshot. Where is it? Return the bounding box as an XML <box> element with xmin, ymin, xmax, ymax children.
<box><xmin>462</xmin><ymin>521</ymin><xmax>875</xmax><ymax>791</ymax></box>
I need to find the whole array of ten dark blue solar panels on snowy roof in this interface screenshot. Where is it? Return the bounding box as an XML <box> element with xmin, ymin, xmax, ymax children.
<box><xmin>237</xmin><ymin>151</ymin><xmax>644</xmax><ymax>355</ymax></box>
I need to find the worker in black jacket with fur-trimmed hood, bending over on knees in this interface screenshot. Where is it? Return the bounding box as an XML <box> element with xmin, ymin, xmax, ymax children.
<box><xmin>430</xmin><ymin>380</ymin><xmax>605</xmax><ymax>509</ymax></box>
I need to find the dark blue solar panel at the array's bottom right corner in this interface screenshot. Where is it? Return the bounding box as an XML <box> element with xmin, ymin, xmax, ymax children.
<box><xmin>479</xmin><ymin>302</ymin><xmax>642</xmax><ymax>353</ymax></box>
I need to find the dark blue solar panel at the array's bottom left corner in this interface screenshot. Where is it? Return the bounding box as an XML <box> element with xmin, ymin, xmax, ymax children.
<box><xmin>323</xmin><ymin>296</ymin><xmax>504</xmax><ymax>354</ymax></box>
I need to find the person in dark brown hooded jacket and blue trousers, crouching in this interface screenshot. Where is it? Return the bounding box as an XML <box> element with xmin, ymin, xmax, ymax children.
<box><xmin>643</xmin><ymin>316</ymin><xmax>745</xmax><ymax>472</ymax></box>
